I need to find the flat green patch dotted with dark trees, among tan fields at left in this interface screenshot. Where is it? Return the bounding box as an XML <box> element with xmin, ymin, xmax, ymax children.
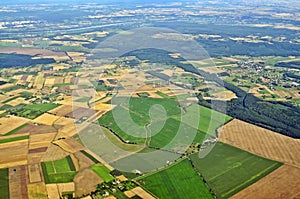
<box><xmin>9</xmin><ymin>103</ymin><xmax>60</xmax><ymax>119</ymax></box>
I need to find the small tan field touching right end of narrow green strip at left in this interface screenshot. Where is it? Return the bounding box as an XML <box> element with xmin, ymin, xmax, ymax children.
<box><xmin>29</xmin><ymin>133</ymin><xmax>56</xmax><ymax>149</ymax></box>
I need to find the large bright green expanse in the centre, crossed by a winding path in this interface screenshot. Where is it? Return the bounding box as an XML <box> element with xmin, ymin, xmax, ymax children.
<box><xmin>99</xmin><ymin>98</ymin><xmax>231</xmax><ymax>148</ymax></box>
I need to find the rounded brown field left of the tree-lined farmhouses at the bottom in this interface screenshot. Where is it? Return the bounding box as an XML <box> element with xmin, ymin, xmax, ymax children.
<box><xmin>74</xmin><ymin>169</ymin><xmax>103</xmax><ymax>197</ymax></box>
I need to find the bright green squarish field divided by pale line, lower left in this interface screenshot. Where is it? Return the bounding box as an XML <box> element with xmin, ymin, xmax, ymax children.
<box><xmin>41</xmin><ymin>156</ymin><xmax>77</xmax><ymax>184</ymax></box>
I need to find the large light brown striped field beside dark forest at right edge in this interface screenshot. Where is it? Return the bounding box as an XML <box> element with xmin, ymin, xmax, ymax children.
<box><xmin>219</xmin><ymin>119</ymin><xmax>300</xmax><ymax>167</ymax></box>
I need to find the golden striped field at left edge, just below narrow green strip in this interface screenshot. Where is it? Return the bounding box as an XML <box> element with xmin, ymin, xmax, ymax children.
<box><xmin>0</xmin><ymin>140</ymin><xmax>28</xmax><ymax>168</ymax></box>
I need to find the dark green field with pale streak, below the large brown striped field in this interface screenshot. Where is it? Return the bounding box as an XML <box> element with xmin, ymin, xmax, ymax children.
<box><xmin>190</xmin><ymin>142</ymin><xmax>282</xmax><ymax>198</ymax></box>
